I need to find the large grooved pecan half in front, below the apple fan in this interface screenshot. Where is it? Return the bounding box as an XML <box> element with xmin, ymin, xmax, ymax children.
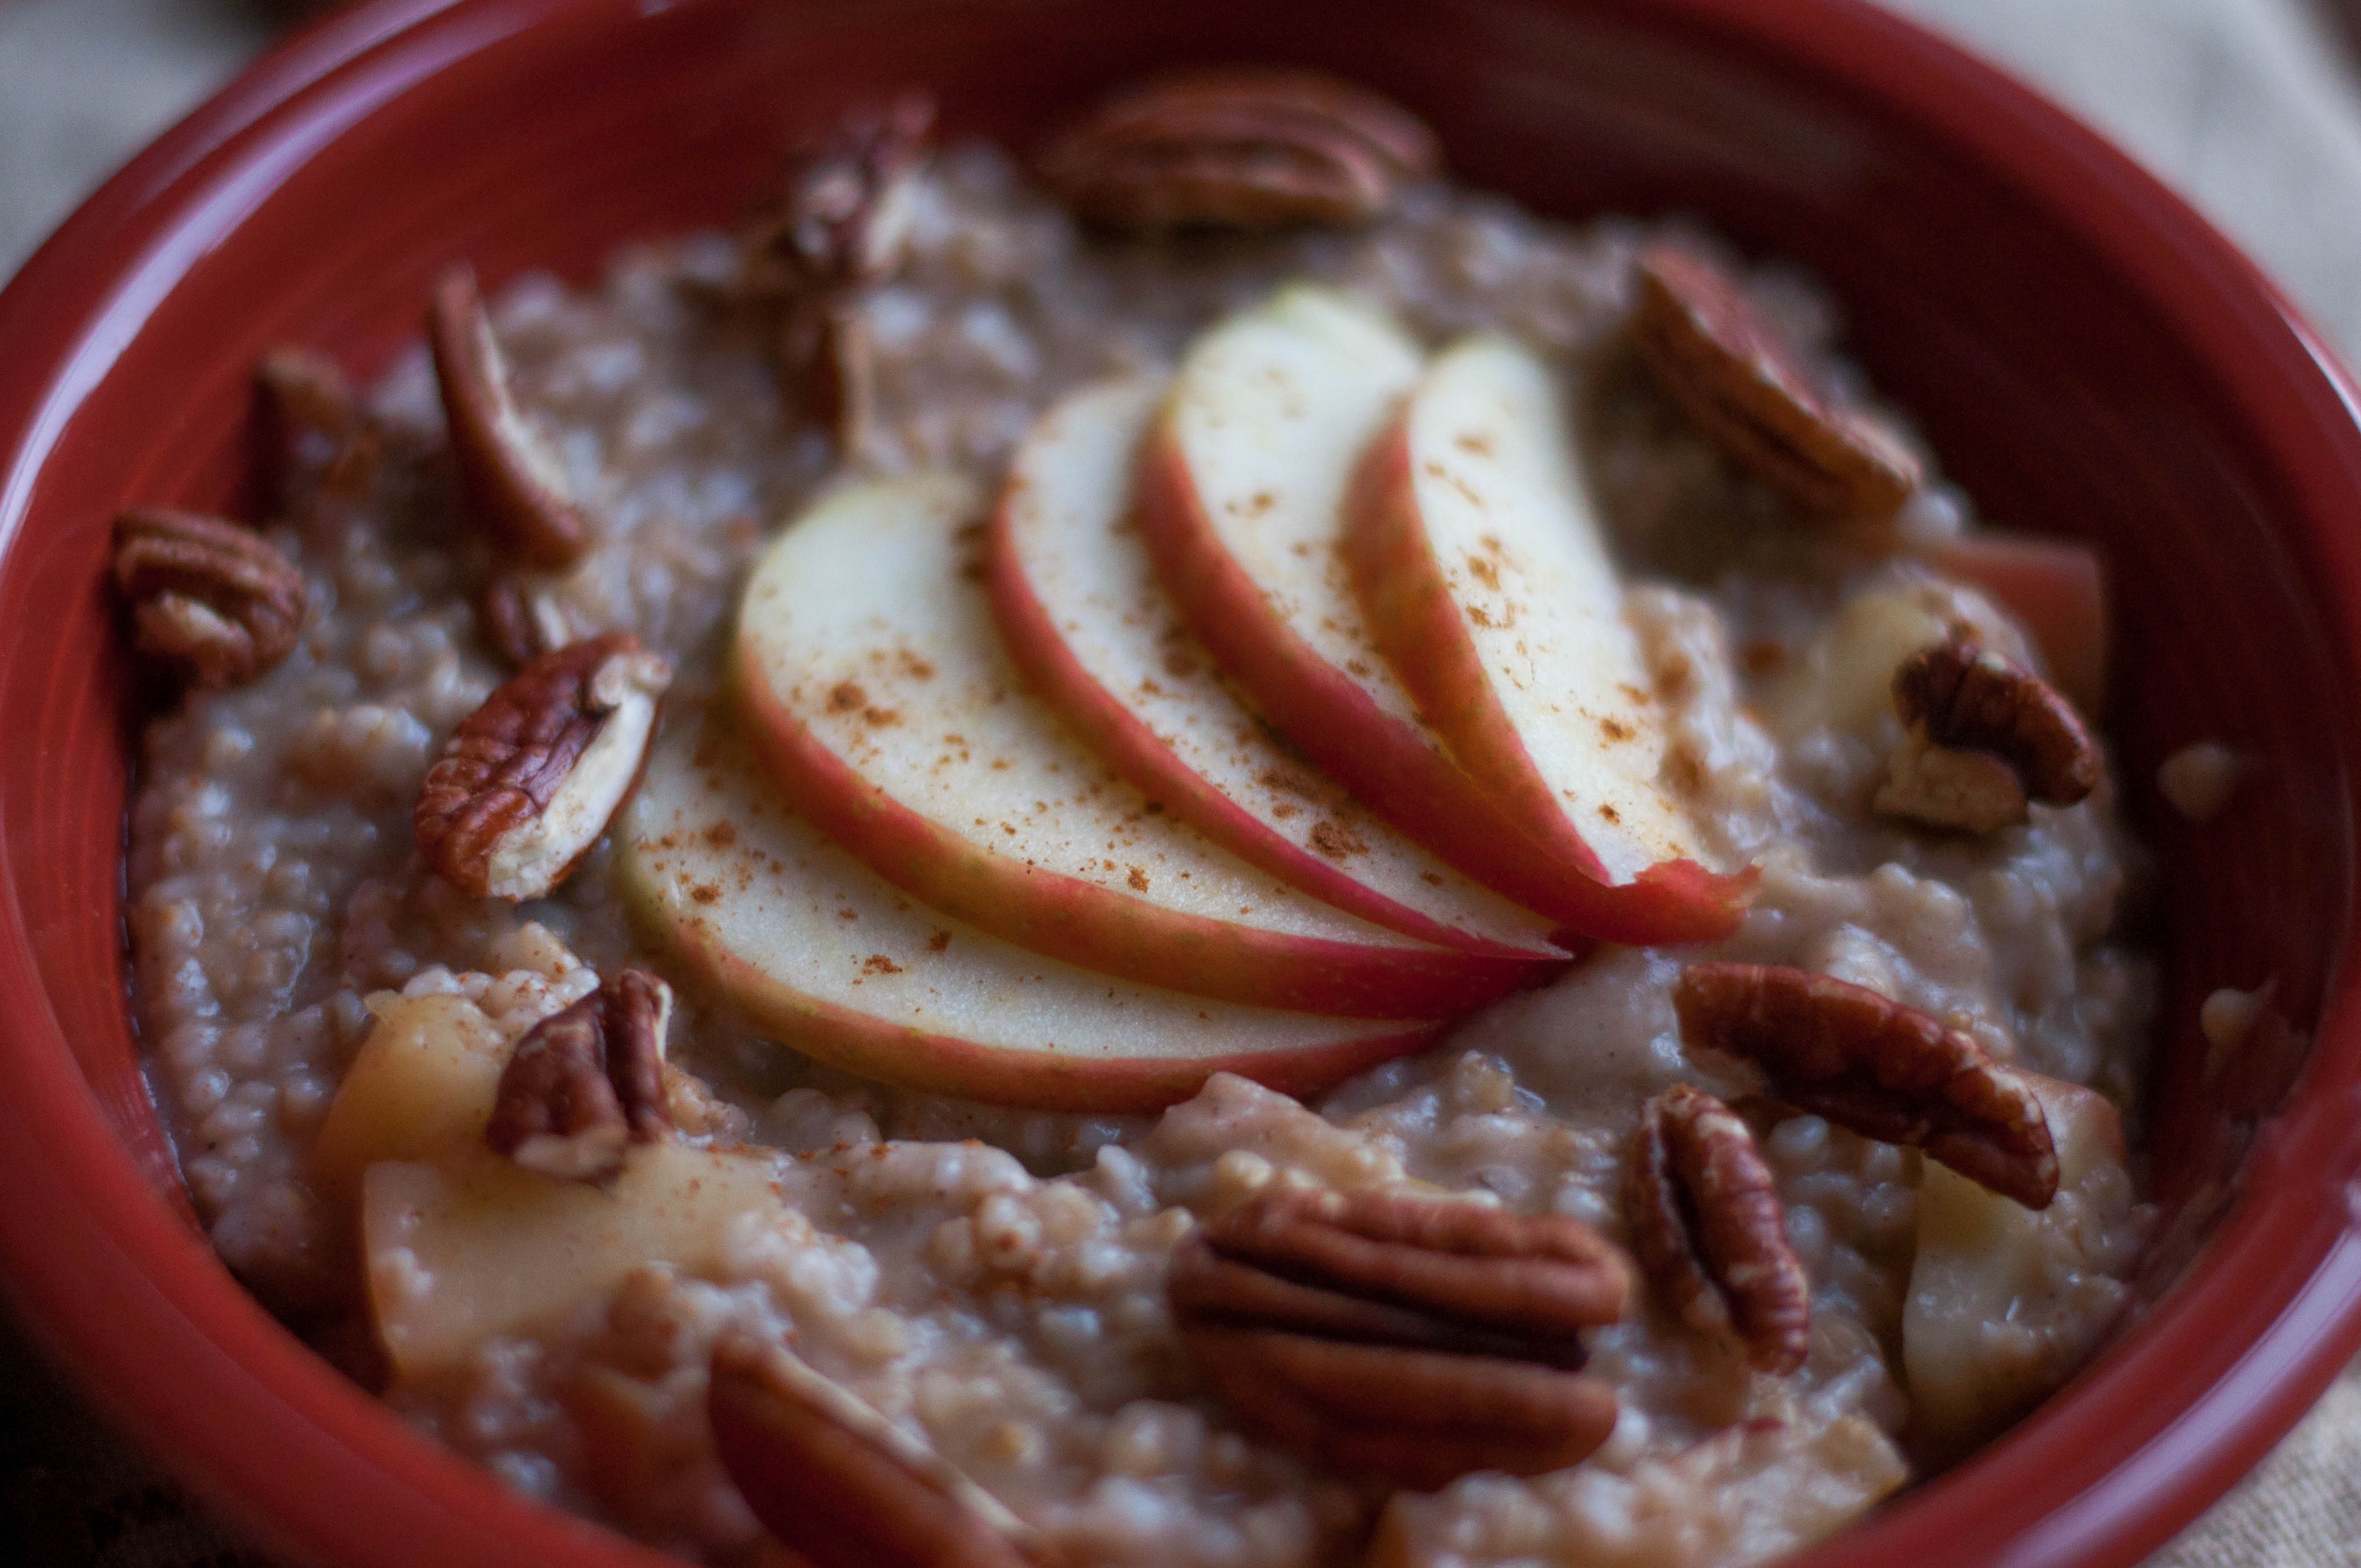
<box><xmin>1167</xmin><ymin>1193</ymin><xmax>1632</xmax><ymax>1488</ymax></box>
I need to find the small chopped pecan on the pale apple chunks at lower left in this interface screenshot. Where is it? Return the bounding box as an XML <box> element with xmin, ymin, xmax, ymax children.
<box><xmin>484</xmin><ymin>968</ymin><xmax>673</xmax><ymax>1181</ymax></box>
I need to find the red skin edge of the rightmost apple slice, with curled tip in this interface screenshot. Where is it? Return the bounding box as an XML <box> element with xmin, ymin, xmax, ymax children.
<box><xmin>1343</xmin><ymin>406</ymin><xmax>1761</xmax><ymax>944</ymax></box>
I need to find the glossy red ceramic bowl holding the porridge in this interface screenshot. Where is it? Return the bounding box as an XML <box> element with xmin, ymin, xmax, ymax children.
<box><xmin>0</xmin><ymin>0</ymin><xmax>2361</xmax><ymax>1568</ymax></box>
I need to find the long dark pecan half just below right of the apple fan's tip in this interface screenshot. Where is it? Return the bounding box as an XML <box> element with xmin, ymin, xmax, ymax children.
<box><xmin>1672</xmin><ymin>964</ymin><xmax>2059</xmax><ymax>1209</ymax></box>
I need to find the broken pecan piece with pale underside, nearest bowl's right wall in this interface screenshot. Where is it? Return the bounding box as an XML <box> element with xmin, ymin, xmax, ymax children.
<box><xmin>1877</xmin><ymin>631</ymin><xmax>2099</xmax><ymax>834</ymax></box>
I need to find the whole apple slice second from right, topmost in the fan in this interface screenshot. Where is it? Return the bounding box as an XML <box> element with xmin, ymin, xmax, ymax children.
<box><xmin>1140</xmin><ymin>286</ymin><xmax>1718</xmax><ymax>935</ymax></box>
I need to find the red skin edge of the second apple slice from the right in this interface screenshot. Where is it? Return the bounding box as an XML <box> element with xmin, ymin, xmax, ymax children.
<box><xmin>1138</xmin><ymin>421</ymin><xmax>1752</xmax><ymax>944</ymax></box>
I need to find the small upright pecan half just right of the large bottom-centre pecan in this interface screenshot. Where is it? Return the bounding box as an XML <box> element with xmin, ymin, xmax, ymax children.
<box><xmin>1624</xmin><ymin>1084</ymin><xmax>1811</xmax><ymax>1375</ymax></box>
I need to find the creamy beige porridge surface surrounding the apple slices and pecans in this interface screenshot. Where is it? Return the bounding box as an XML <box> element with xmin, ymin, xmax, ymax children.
<box><xmin>130</xmin><ymin>134</ymin><xmax>2156</xmax><ymax>1566</ymax></box>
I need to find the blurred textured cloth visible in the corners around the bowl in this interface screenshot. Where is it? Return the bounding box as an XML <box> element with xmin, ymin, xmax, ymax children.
<box><xmin>0</xmin><ymin>0</ymin><xmax>2361</xmax><ymax>1568</ymax></box>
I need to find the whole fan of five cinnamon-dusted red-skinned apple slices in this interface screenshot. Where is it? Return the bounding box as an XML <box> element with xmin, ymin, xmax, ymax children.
<box><xmin>621</xmin><ymin>288</ymin><xmax>1752</xmax><ymax>1108</ymax></box>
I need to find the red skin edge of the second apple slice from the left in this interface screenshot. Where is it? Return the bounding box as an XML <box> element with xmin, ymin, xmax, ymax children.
<box><xmin>734</xmin><ymin>654</ymin><xmax>1551</xmax><ymax>1018</ymax></box>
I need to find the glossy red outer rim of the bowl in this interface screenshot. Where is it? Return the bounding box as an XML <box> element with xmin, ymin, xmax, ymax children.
<box><xmin>0</xmin><ymin>0</ymin><xmax>2361</xmax><ymax>1568</ymax></box>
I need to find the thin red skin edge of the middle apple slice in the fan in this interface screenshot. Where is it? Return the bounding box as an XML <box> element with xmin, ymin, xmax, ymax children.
<box><xmin>984</xmin><ymin>491</ymin><xmax>1568</xmax><ymax>980</ymax></box>
